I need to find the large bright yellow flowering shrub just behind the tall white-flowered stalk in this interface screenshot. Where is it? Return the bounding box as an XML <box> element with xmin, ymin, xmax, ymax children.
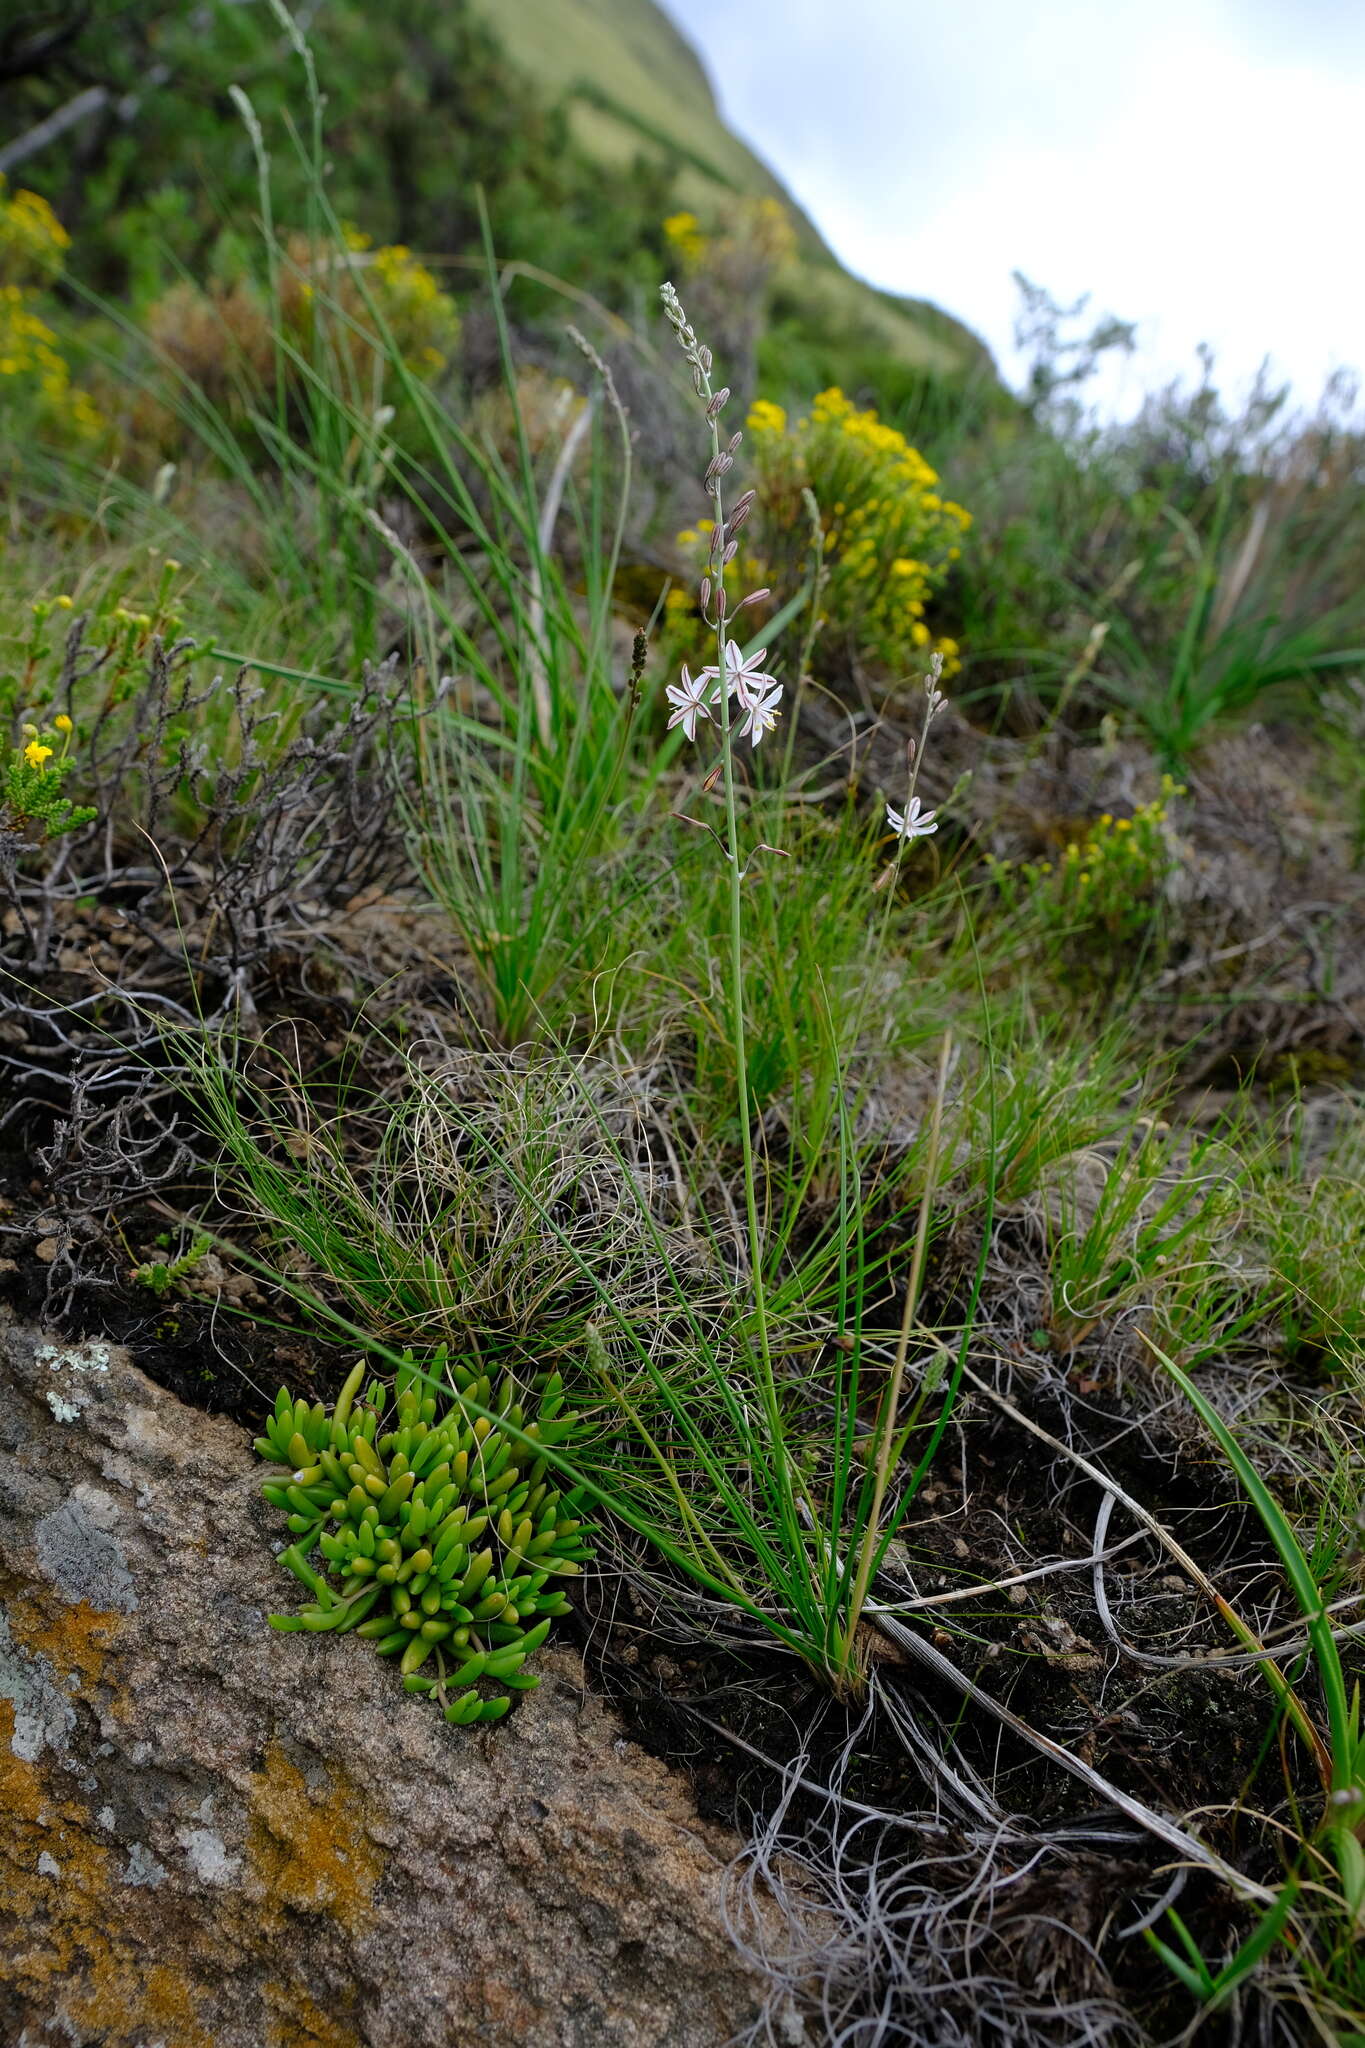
<box><xmin>679</xmin><ymin>389</ymin><xmax>972</xmax><ymax>676</ymax></box>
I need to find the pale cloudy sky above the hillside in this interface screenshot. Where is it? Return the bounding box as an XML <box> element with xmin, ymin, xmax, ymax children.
<box><xmin>665</xmin><ymin>0</ymin><xmax>1365</xmax><ymax>412</ymax></box>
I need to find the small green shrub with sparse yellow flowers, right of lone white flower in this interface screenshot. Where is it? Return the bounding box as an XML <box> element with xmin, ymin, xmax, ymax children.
<box><xmin>988</xmin><ymin>776</ymin><xmax>1185</xmax><ymax>950</ymax></box>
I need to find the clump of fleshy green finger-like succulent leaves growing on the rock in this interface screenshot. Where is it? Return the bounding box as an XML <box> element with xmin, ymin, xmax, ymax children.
<box><xmin>256</xmin><ymin>1348</ymin><xmax>589</xmax><ymax>1726</ymax></box>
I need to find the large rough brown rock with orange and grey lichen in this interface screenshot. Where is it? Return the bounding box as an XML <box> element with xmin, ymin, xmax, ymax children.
<box><xmin>0</xmin><ymin>1327</ymin><xmax>800</xmax><ymax>2048</ymax></box>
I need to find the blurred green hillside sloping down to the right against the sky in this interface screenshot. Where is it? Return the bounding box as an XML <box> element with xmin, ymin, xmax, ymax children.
<box><xmin>0</xmin><ymin>0</ymin><xmax>999</xmax><ymax>408</ymax></box>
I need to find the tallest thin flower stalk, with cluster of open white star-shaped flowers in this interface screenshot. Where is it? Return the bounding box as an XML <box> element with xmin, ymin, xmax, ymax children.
<box><xmin>661</xmin><ymin>285</ymin><xmax>804</xmax><ymax>1550</ymax></box>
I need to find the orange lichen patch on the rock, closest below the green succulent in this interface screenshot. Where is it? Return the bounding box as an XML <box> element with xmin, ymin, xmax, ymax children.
<box><xmin>248</xmin><ymin>1743</ymin><xmax>383</xmax><ymax>1933</ymax></box>
